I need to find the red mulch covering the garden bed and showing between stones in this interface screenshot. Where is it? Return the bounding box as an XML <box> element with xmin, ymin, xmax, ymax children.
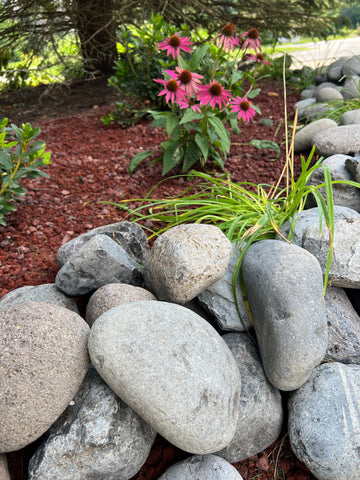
<box><xmin>0</xmin><ymin>77</ymin><xmax>315</xmax><ymax>480</ymax></box>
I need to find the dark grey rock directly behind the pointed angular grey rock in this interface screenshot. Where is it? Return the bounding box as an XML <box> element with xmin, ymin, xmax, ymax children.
<box><xmin>56</xmin><ymin>220</ymin><xmax>150</xmax><ymax>267</ymax></box>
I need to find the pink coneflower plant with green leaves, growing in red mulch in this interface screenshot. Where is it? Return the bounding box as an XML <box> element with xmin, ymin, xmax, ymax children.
<box><xmin>129</xmin><ymin>23</ymin><xmax>278</xmax><ymax>175</ymax></box>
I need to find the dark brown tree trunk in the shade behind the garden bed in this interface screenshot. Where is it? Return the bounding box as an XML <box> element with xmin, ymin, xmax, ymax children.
<box><xmin>73</xmin><ymin>0</ymin><xmax>118</xmax><ymax>76</ymax></box>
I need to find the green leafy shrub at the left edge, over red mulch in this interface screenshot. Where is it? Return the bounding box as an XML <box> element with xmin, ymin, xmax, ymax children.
<box><xmin>0</xmin><ymin>118</ymin><xmax>51</xmax><ymax>225</ymax></box>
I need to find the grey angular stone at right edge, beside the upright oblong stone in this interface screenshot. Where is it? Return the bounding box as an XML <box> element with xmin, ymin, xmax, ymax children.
<box><xmin>325</xmin><ymin>286</ymin><xmax>360</xmax><ymax>364</ymax></box>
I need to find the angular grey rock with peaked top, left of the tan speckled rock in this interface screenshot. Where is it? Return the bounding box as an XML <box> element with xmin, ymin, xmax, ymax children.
<box><xmin>55</xmin><ymin>235</ymin><xmax>142</xmax><ymax>296</ymax></box>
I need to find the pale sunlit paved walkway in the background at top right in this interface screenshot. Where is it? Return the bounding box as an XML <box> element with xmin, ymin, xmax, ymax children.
<box><xmin>278</xmin><ymin>37</ymin><xmax>360</xmax><ymax>68</ymax></box>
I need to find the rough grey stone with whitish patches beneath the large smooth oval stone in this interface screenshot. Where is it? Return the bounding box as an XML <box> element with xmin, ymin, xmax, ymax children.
<box><xmin>28</xmin><ymin>367</ymin><xmax>156</xmax><ymax>480</ymax></box>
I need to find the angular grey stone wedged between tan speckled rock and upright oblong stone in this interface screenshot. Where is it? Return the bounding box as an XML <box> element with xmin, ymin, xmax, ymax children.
<box><xmin>197</xmin><ymin>243</ymin><xmax>251</xmax><ymax>332</ymax></box>
